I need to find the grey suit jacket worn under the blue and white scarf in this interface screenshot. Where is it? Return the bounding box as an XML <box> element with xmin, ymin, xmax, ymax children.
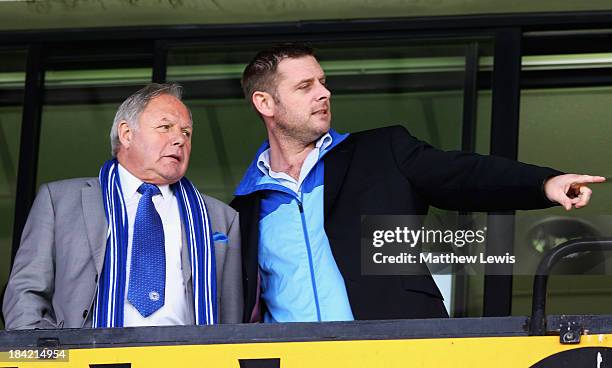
<box><xmin>3</xmin><ymin>178</ymin><xmax>243</xmax><ymax>329</ymax></box>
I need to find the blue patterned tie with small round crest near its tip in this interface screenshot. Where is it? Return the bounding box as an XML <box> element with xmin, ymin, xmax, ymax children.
<box><xmin>128</xmin><ymin>183</ymin><xmax>166</xmax><ymax>317</ymax></box>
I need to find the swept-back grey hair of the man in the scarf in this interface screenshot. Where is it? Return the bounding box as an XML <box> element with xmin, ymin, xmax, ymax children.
<box><xmin>110</xmin><ymin>83</ymin><xmax>185</xmax><ymax>157</ymax></box>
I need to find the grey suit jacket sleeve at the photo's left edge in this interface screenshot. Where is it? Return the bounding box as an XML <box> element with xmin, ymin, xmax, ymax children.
<box><xmin>3</xmin><ymin>185</ymin><xmax>58</xmax><ymax>330</ymax></box>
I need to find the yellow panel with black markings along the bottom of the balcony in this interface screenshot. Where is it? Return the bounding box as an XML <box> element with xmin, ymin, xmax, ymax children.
<box><xmin>0</xmin><ymin>334</ymin><xmax>612</xmax><ymax>368</ymax></box>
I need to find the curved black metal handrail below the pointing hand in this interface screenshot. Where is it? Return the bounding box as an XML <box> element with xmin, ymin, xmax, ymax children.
<box><xmin>529</xmin><ymin>238</ymin><xmax>612</xmax><ymax>336</ymax></box>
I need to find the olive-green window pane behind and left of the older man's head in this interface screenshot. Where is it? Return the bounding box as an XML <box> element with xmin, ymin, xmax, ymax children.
<box><xmin>37</xmin><ymin>67</ymin><xmax>151</xmax><ymax>185</ymax></box>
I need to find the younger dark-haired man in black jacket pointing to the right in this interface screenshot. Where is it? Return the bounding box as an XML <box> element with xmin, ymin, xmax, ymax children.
<box><xmin>232</xmin><ymin>44</ymin><xmax>605</xmax><ymax>322</ymax></box>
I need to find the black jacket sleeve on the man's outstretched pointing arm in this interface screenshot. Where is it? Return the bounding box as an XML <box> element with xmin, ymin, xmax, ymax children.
<box><xmin>390</xmin><ymin>126</ymin><xmax>563</xmax><ymax>211</ymax></box>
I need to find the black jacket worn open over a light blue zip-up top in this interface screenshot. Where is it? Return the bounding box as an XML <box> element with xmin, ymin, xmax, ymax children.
<box><xmin>231</xmin><ymin>126</ymin><xmax>561</xmax><ymax>322</ymax></box>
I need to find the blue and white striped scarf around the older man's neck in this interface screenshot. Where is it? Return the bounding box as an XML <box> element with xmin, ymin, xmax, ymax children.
<box><xmin>92</xmin><ymin>159</ymin><xmax>217</xmax><ymax>328</ymax></box>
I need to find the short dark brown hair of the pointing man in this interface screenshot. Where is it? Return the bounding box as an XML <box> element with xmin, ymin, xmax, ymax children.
<box><xmin>241</xmin><ymin>43</ymin><xmax>314</xmax><ymax>101</ymax></box>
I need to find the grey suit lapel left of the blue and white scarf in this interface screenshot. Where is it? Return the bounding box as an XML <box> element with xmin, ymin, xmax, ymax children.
<box><xmin>81</xmin><ymin>178</ymin><xmax>108</xmax><ymax>275</ymax></box>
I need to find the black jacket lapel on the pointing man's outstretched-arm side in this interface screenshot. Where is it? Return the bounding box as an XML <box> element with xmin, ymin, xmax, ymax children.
<box><xmin>323</xmin><ymin>136</ymin><xmax>355</xmax><ymax>219</ymax></box>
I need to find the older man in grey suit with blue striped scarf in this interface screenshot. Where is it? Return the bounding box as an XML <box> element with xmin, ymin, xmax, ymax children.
<box><xmin>3</xmin><ymin>84</ymin><xmax>242</xmax><ymax>329</ymax></box>
